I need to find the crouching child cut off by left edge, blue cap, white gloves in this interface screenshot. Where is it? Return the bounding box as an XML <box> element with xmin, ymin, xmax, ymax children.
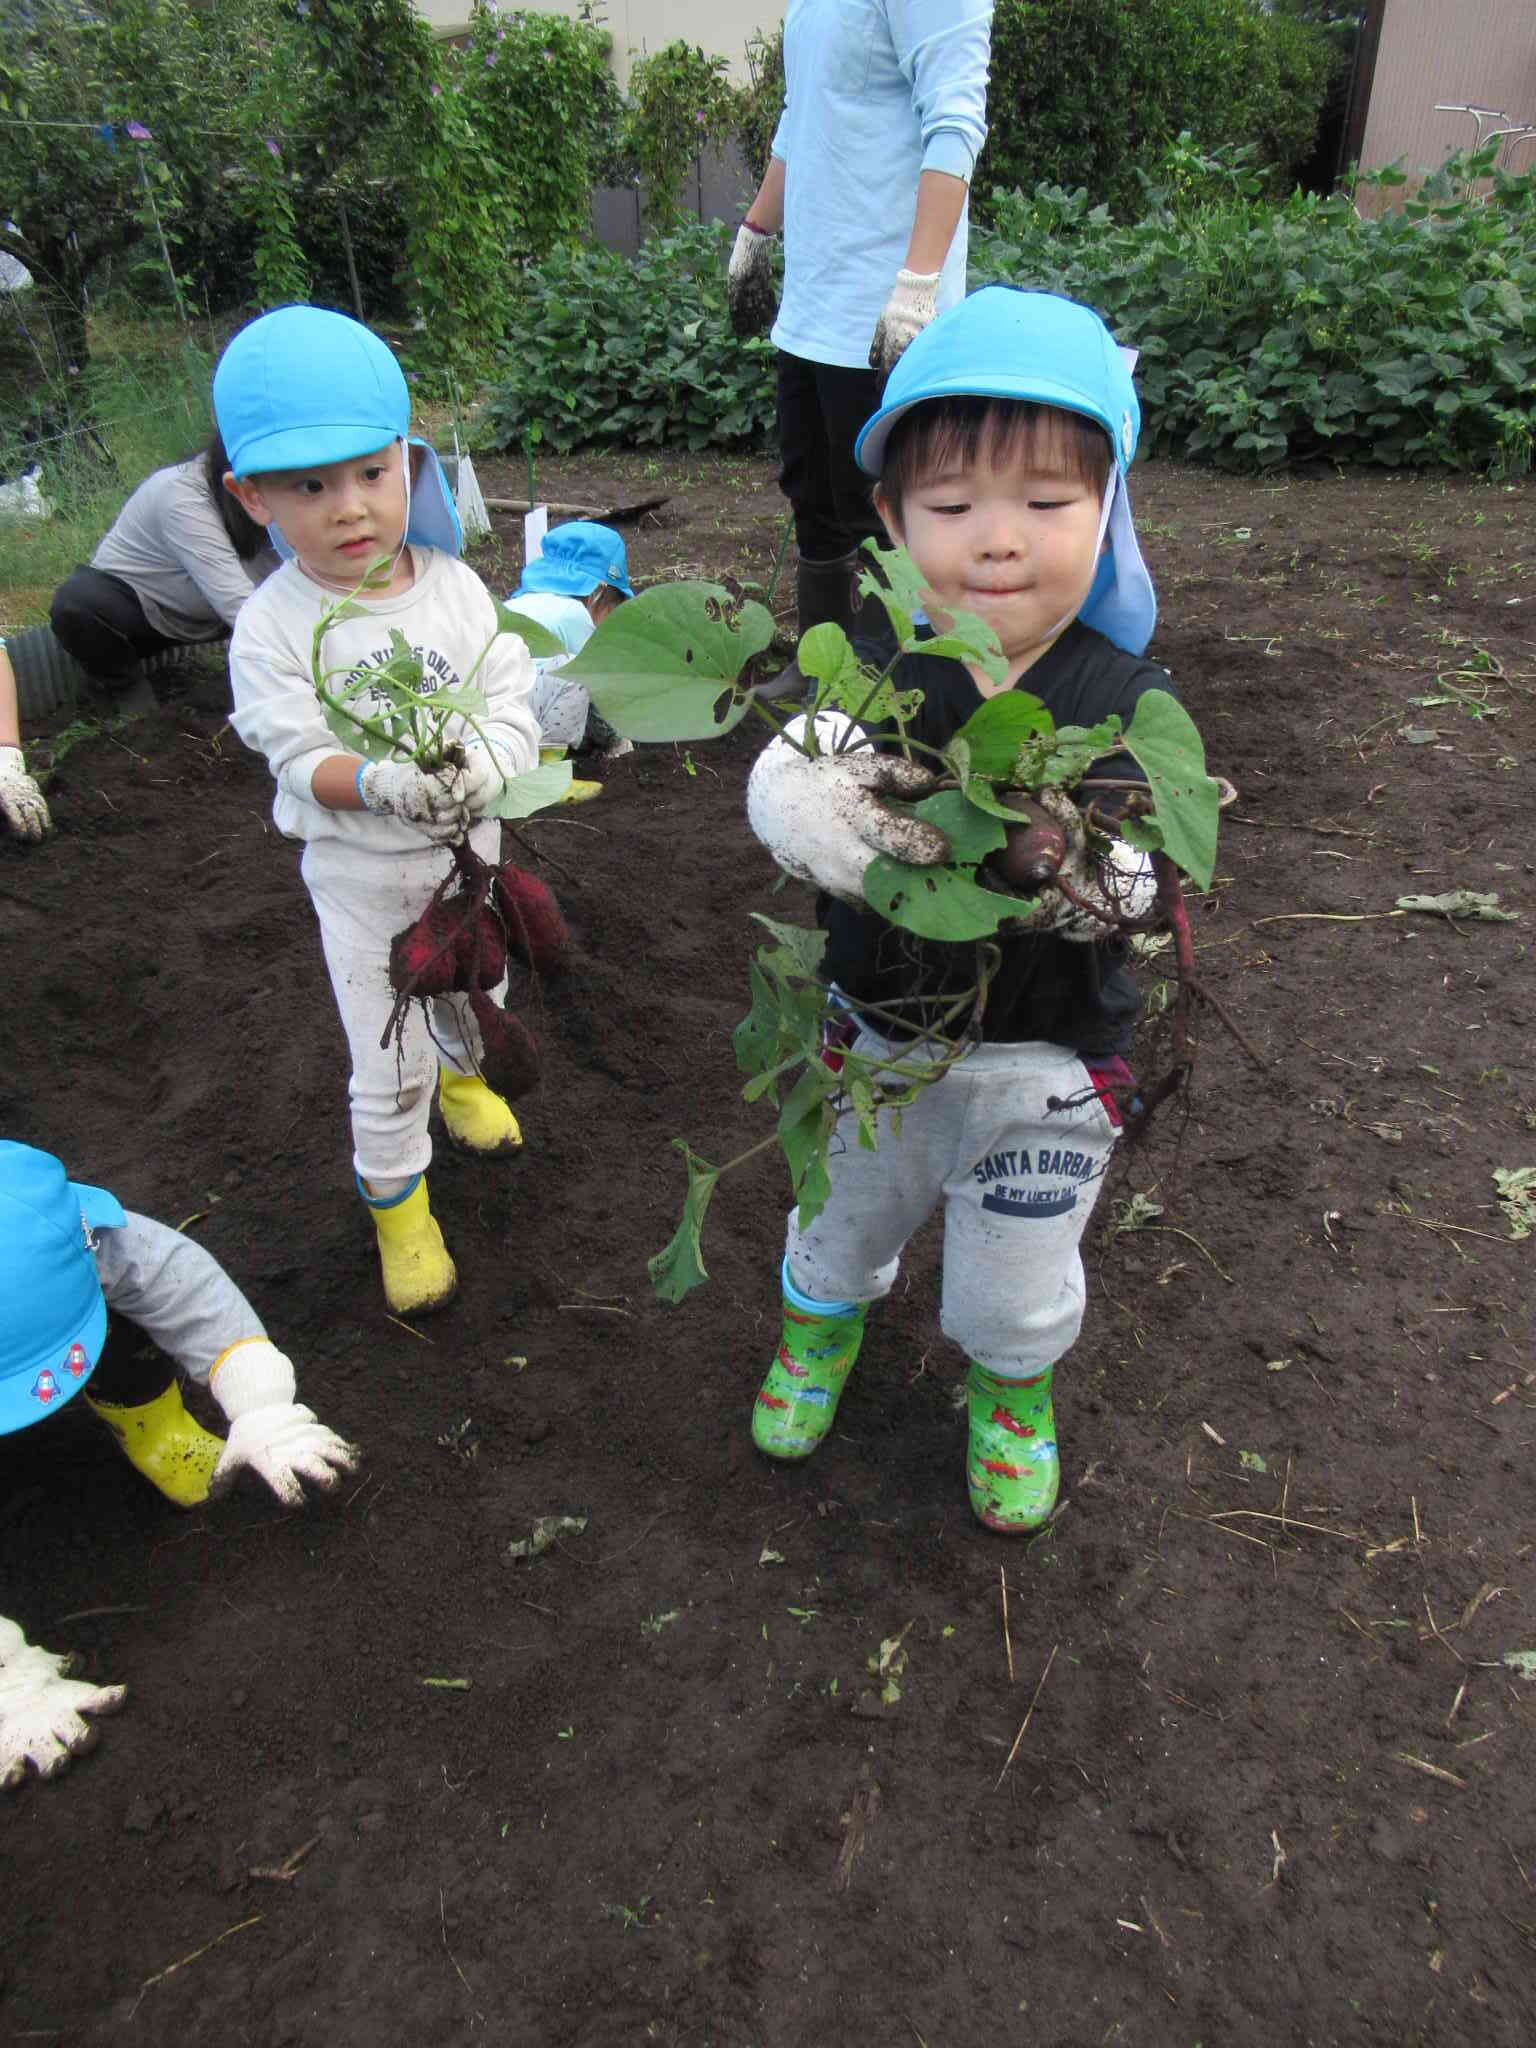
<box><xmin>0</xmin><ymin>1141</ymin><xmax>356</xmax><ymax>1786</ymax></box>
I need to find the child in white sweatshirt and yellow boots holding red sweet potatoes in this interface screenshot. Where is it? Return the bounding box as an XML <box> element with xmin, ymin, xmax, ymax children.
<box><xmin>213</xmin><ymin>305</ymin><xmax>539</xmax><ymax>1315</ymax></box>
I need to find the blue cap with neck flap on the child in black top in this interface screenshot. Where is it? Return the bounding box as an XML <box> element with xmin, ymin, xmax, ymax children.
<box><xmin>854</xmin><ymin>285</ymin><xmax>1157</xmax><ymax>653</ymax></box>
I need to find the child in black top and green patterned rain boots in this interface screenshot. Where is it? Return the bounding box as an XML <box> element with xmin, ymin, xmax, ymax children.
<box><xmin>748</xmin><ymin>285</ymin><xmax>1169</xmax><ymax>1534</ymax></box>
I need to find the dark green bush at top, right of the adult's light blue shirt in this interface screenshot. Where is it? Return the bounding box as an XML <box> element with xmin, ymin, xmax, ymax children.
<box><xmin>975</xmin><ymin>0</ymin><xmax>1331</xmax><ymax>213</ymax></box>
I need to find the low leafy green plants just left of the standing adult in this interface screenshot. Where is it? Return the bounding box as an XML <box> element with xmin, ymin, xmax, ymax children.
<box><xmin>479</xmin><ymin>227</ymin><xmax>774</xmax><ymax>451</ymax></box>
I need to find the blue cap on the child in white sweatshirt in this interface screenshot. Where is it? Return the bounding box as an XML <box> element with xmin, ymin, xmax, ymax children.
<box><xmin>213</xmin><ymin>305</ymin><xmax>463</xmax><ymax>557</ymax></box>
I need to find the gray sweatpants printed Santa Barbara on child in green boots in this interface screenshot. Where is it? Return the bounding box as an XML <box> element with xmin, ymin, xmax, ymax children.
<box><xmin>784</xmin><ymin>1030</ymin><xmax>1128</xmax><ymax>1378</ymax></box>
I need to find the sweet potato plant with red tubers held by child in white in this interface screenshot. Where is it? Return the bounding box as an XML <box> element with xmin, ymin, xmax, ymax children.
<box><xmin>309</xmin><ymin>577</ymin><xmax>571</xmax><ymax>1102</ymax></box>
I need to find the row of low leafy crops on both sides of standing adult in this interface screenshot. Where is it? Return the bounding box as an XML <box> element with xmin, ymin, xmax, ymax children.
<box><xmin>485</xmin><ymin>147</ymin><xmax>1536</xmax><ymax>475</ymax></box>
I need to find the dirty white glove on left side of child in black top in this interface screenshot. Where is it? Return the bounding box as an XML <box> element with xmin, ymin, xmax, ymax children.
<box><xmin>748</xmin><ymin>711</ymin><xmax>950</xmax><ymax>905</ymax></box>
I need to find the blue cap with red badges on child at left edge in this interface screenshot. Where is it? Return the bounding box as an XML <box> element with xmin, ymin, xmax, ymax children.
<box><xmin>0</xmin><ymin>1139</ymin><xmax>127</xmax><ymax>1436</ymax></box>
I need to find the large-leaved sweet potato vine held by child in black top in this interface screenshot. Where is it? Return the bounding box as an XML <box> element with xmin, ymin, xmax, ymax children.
<box><xmin>567</xmin><ymin>545</ymin><xmax>1221</xmax><ymax>1303</ymax></box>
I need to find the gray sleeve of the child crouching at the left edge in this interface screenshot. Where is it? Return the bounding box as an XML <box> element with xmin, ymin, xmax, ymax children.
<box><xmin>96</xmin><ymin>1210</ymin><xmax>266</xmax><ymax>1382</ymax></box>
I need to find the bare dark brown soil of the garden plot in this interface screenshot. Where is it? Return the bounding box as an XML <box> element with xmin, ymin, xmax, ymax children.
<box><xmin>0</xmin><ymin>457</ymin><xmax>1536</xmax><ymax>2048</ymax></box>
